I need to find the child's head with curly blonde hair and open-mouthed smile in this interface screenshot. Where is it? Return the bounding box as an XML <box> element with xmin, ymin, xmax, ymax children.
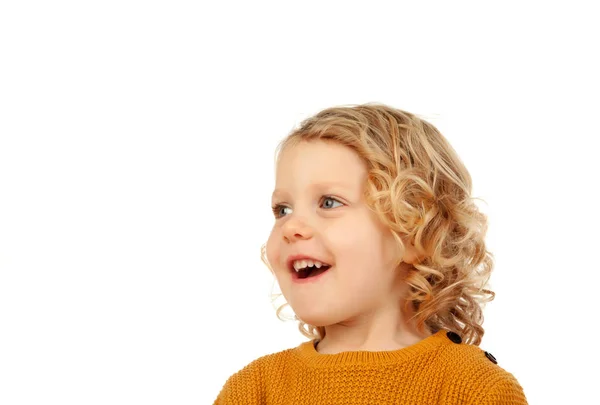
<box><xmin>262</xmin><ymin>104</ymin><xmax>494</xmax><ymax>344</ymax></box>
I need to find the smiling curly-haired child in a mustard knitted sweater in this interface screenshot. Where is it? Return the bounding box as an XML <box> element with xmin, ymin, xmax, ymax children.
<box><xmin>215</xmin><ymin>103</ymin><xmax>527</xmax><ymax>405</ymax></box>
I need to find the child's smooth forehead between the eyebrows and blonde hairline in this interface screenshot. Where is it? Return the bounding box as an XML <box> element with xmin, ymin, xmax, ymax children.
<box><xmin>273</xmin><ymin>141</ymin><xmax>367</xmax><ymax>195</ymax></box>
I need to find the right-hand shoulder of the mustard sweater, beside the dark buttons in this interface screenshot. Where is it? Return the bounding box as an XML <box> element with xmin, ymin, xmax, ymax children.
<box><xmin>439</xmin><ymin>334</ymin><xmax>527</xmax><ymax>404</ymax></box>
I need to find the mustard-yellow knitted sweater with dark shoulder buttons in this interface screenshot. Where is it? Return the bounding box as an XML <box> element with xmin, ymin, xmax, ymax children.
<box><xmin>214</xmin><ymin>330</ymin><xmax>527</xmax><ymax>405</ymax></box>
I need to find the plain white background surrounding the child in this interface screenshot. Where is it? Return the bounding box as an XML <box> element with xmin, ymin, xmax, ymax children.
<box><xmin>0</xmin><ymin>1</ymin><xmax>600</xmax><ymax>405</ymax></box>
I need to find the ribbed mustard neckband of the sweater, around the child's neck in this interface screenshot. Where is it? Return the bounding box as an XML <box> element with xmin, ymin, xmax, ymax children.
<box><xmin>294</xmin><ymin>329</ymin><xmax>450</xmax><ymax>367</ymax></box>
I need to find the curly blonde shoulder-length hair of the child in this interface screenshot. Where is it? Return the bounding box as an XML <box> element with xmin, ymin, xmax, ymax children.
<box><xmin>261</xmin><ymin>103</ymin><xmax>495</xmax><ymax>345</ymax></box>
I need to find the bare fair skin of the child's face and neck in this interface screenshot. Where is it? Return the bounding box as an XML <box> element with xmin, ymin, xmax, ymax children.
<box><xmin>267</xmin><ymin>140</ymin><xmax>430</xmax><ymax>354</ymax></box>
